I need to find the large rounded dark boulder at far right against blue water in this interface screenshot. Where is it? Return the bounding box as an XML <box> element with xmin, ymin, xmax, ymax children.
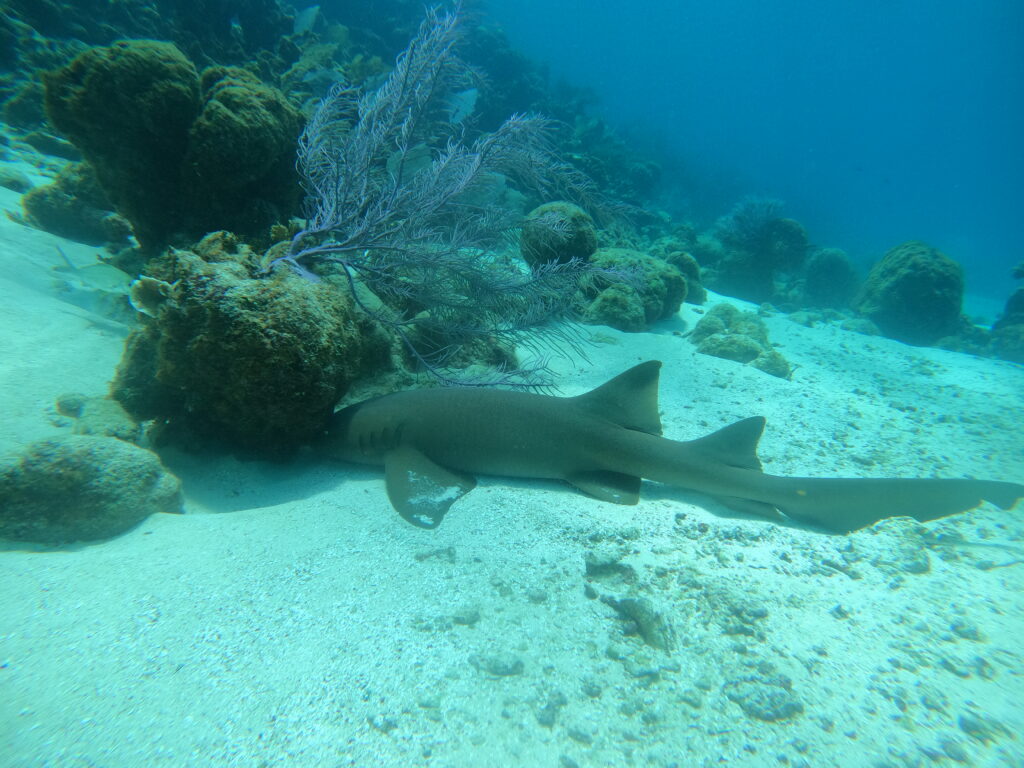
<box><xmin>854</xmin><ymin>241</ymin><xmax>964</xmax><ymax>345</ymax></box>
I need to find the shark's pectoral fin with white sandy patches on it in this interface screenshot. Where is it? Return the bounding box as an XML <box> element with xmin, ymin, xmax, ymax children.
<box><xmin>384</xmin><ymin>445</ymin><xmax>476</xmax><ymax>528</ymax></box>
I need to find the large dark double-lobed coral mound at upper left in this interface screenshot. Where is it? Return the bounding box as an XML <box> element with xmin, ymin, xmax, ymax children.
<box><xmin>43</xmin><ymin>40</ymin><xmax>301</xmax><ymax>252</ymax></box>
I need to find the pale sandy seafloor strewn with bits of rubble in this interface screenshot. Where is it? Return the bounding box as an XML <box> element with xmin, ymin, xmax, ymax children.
<box><xmin>0</xmin><ymin>182</ymin><xmax>1024</xmax><ymax>768</ymax></box>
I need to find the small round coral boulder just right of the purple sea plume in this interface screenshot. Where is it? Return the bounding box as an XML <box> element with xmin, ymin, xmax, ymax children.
<box><xmin>519</xmin><ymin>201</ymin><xmax>597</xmax><ymax>267</ymax></box>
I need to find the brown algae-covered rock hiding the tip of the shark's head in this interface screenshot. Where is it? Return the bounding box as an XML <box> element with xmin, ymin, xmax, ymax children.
<box><xmin>112</xmin><ymin>232</ymin><xmax>390</xmax><ymax>455</ymax></box>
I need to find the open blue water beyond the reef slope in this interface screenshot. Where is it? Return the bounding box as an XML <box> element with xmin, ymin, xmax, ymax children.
<box><xmin>488</xmin><ymin>0</ymin><xmax>1024</xmax><ymax>299</ymax></box>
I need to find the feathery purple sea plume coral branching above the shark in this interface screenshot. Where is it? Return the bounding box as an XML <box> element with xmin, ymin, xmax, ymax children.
<box><xmin>270</xmin><ymin>4</ymin><xmax>594</xmax><ymax>383</ymax></box>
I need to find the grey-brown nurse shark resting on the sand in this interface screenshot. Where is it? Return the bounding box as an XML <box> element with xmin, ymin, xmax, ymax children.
<box><xmin>326</xmin><ymin>360</ymin><xmax>1024</xmax><ymax>532</ymax></box>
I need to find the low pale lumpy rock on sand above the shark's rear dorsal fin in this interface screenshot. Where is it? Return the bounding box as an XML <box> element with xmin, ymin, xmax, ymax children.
<box><xmin>690</xmin><ymin>304</ymin><xmax>792</xmax><ymax>379</ymax></box>
